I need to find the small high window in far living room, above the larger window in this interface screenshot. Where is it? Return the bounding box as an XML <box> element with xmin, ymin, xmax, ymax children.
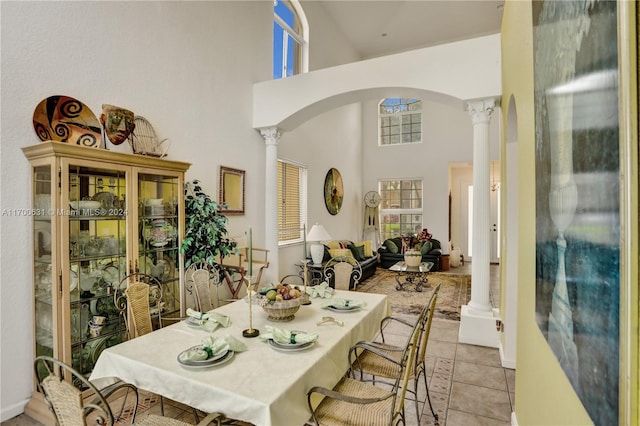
<box><xmin>378</xmin><ymin>98</ymin><xmax>422</xmax><ymax>145</ymax></box>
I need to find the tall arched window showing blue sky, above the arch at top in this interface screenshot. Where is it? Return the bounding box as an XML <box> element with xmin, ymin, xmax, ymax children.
<box><xmin>273</xmin><ymin>0</ymin><xmax>309</xmax><ymax>79</ymax></box>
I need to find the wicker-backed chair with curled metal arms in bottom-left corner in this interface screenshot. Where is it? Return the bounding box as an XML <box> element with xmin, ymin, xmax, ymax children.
<box><xmin>34</xmin><ymin>356</ymin><xmax>224</xmax><ymax>426</ymax></box>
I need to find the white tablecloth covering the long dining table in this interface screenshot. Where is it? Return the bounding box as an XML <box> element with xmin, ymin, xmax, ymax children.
<box><xmin>91</xmin><ymin>291</ymin><xmax>389</xmax><ymax>426</ymax></box>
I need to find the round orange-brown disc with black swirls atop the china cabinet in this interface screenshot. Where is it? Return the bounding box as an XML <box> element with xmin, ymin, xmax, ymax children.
<box><xmin>33</xmin><ymin>96</ymin><xmax>102</xmax><ymax>148</ymax></box>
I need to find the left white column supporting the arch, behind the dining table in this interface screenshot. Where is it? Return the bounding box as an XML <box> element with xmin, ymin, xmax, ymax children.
<box><xmin>259</xmin><ymin>127</ymin><xmax>280</xmax><ymax>282</ymax></box>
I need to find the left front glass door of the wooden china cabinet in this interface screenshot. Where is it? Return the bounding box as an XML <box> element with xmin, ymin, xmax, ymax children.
<box><xmin>63</xmin><ymin>165</ymin><xmax>128</xmax><ymax>374</ymax></box>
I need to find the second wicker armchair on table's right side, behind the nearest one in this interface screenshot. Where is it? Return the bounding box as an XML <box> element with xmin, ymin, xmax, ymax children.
<box><xmin>349</xmin><ymin>284</ymin><xmax>440</xmax><ymax>424</ymax></box>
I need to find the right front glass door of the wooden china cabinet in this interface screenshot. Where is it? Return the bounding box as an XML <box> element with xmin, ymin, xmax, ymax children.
<box><xmin>137</xmin><ymin>173</ymin><xmax>182</xmax><ymax>321</ymax></box>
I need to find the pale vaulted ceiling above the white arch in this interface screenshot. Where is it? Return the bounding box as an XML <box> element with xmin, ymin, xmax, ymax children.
<box><xmin>316</xmin><ymin>0</ymin><xmax>504</xmax><ymax>59</ymax></box>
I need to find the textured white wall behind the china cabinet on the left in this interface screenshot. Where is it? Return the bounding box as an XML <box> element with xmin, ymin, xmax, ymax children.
<box><xmin>0</xmin><ymin>1</ymin><xmax>273</xmax><ymax>420</ymax></box>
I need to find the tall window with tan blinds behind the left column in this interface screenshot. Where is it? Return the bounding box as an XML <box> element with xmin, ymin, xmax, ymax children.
<box><xmin>278</xmin><ymin>160</ymin><xmax>307</xmax><ymax>244</ymax></box>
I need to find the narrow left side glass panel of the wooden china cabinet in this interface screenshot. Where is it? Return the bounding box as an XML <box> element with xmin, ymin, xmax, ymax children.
<box><xmin>32</xmin><ymin>165</ymin><xmax>58</xmax><ymax>362</ymax></box>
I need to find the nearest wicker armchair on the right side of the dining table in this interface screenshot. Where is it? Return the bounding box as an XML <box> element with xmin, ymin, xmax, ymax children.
<box><xmin>307</xmin><ymin>322</ymin><xmax>419</xmax><ymax>426</ymax></box>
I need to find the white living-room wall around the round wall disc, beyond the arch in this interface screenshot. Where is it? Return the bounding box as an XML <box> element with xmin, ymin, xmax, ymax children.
<box><xmin>274</xmin><ymin>1</ymin><xmax>362</xmax><ymax>278</ymax></box>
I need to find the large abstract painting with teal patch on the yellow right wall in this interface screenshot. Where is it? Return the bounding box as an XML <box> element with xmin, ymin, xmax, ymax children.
<box><xmin>533</xmin><ymin>0</ymin><xmax>621</xmax><ymax>425</ymax></box>
